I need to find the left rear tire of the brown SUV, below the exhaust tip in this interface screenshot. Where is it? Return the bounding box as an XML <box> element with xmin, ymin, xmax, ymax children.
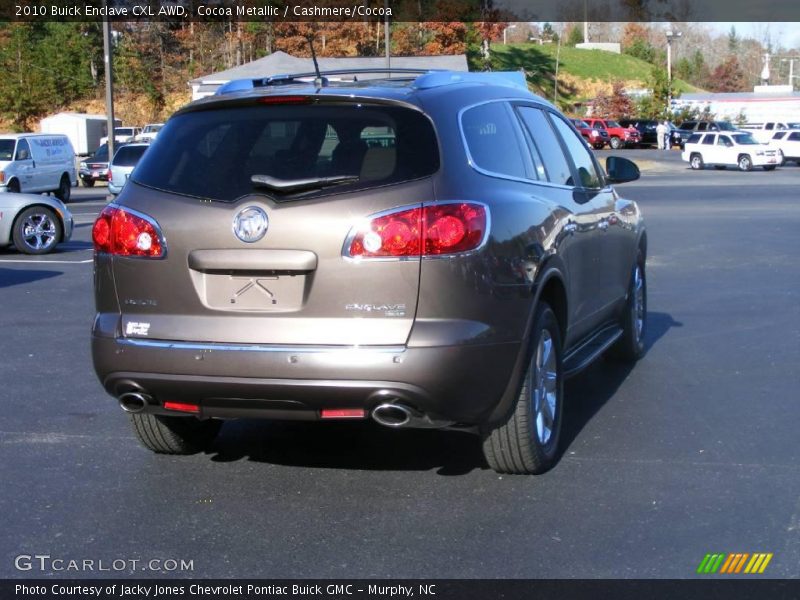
<box><xmin>130</xmin><ymin>413</ymin><xmax>222</xmax><ymax>454</ymax></box>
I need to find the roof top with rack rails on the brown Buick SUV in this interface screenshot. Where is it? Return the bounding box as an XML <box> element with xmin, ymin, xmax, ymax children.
<box><xmin>215</xmin><ymin>69</ymin><xmax>528</xmax><ymax>96</ymax></box>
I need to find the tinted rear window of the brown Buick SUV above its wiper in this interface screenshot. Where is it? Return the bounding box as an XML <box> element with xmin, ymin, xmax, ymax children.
<box><xmin>135</xmin><ymin>104</ymin><xmax>439</xmax><ymax>202</ymax></box>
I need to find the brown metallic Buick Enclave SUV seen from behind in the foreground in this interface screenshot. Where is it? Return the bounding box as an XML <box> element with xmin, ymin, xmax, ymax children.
<box><xmin>92</xmin><ymin>72</ymin><xmax>647</xmax><ymax>473</ymax></box>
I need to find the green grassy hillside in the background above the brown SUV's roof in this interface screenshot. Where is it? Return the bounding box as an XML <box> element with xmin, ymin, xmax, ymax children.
<box><xmin>484</xmin><ymin>44</ymin><xmax>697</xmax><ymax>109</ymax></box>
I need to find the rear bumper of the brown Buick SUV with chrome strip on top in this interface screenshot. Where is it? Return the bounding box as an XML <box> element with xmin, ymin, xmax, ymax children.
<box><xmin>92</xmin><ymin>335</ymin><xmax>520</xmax><ymax>424</ymax></box>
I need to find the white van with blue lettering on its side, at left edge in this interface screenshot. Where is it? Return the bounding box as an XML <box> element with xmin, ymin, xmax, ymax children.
<box><xmin>0</xmin><ymin>133</ymin><xmax>78</xmax><ymax>202</ymax></box>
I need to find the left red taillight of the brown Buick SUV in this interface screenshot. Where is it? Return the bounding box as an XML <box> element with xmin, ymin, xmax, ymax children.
<box><xmin>92</xmin><ymin>205</ymin><xmax>165</xmax><ymax>258</ymax></box>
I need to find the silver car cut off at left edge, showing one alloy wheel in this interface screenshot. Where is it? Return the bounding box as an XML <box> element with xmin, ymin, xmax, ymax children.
<box><xmin>0</xmin><ymin>193</ymin><xmax>73</xmax><ymax>254</ymax></box>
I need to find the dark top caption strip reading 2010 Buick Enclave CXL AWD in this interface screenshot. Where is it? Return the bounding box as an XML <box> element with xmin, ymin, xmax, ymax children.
<box><xmin>0</xmin><ymin>0</ymin><xmax>800</xmax><ymax>23</ymax></box>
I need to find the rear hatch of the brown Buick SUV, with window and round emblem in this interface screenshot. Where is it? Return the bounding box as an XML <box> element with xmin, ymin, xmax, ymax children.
<box><xmin>106</xmin><ymin>96</ymin><xmax>439</xmax><ymax>345</ymax></box>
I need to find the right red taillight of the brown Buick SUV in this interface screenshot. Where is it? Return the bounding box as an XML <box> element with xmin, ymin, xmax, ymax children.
<box><xmin>345</xmin><ymin>202</ymin><xmax>488</xmax><ymax>258</ymax></box>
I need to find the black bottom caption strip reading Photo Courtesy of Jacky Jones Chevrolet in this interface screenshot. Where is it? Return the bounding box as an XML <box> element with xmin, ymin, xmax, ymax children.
<box><xmin>0</xmin><ymin>579</ymin><xmax>800</xmax><ymax>600</ymax></box>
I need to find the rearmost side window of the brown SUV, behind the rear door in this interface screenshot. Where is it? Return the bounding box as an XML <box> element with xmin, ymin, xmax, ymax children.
<box><xmin>461</xmin><ymin>102</ymin><xmax>528</xmax><ymax>179</ymax></box>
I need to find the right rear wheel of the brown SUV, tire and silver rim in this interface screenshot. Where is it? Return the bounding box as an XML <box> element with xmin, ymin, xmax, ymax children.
<box><xmin>483</xmin><ymin>303</ymin><xmax>564</xmax><ymax>475</ymax></box>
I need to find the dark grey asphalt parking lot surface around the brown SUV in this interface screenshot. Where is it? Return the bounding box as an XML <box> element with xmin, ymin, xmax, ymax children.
<box><xmin>0</xmin><ymin>155</ymin><xmax>800</xmax><ymax>578</ymax></box>
